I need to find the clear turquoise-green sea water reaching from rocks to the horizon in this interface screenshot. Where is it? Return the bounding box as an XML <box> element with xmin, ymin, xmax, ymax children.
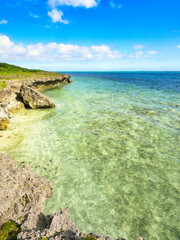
<box><xmin>8</xmin><ymin>73</ymin><xmax>180</xmax><ymax>240</ymax></box>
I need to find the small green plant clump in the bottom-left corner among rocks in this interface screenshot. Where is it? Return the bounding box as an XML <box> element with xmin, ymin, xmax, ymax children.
<box><xmin>0</xmin><ymin>221</ymin><xmax>20</xmax><ymax>240</ymax></box>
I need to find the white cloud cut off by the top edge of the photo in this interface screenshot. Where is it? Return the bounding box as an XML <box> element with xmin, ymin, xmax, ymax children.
<box><xmin>48</xmin><ymin>0</ymin><xmax>99</xmax><ymax>8</ymax></box>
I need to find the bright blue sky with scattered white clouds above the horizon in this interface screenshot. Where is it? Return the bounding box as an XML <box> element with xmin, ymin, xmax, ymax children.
<box><xmin>0</xmin><ymin>0</ymin><xmax>180</xmax><ymax>71</ymax></box>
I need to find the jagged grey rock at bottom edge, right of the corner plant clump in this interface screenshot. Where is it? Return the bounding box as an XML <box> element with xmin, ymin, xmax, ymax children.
<box><xmin>17</xmin><ymin>208</ymin><xmax>86</xmax><ymax>240</ymax></box>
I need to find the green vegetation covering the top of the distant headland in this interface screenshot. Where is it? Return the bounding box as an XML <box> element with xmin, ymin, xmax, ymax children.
<box><xmin>0</xmin><ymin>63</ymin><xmax>63</xmax><ymax>80</ymax></box>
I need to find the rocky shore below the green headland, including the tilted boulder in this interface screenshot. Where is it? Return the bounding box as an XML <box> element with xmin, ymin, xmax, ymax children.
<box><xmin>0</xmin><ymin>75</ymin><xmax>72</xmax><ymax>130</ymax></box>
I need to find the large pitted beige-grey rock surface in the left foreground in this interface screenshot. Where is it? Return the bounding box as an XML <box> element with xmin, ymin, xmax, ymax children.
<box><xmin>0</xmin><ymin>153</ymin><xmax>52</xmax><ymax>226</ymax></box>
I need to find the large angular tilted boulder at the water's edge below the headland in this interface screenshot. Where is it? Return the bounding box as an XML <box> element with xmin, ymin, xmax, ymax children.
<box><xmin>20</xmin><ymin>84</ymin><xmax>55</xmax><ymax>109</ymax></box>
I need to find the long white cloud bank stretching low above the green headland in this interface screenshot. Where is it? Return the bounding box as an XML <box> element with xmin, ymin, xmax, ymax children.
<box><xmin>0</xmin><ymin>35</ymin><xmax>123</xmax><ymax>62</ymax></box>
